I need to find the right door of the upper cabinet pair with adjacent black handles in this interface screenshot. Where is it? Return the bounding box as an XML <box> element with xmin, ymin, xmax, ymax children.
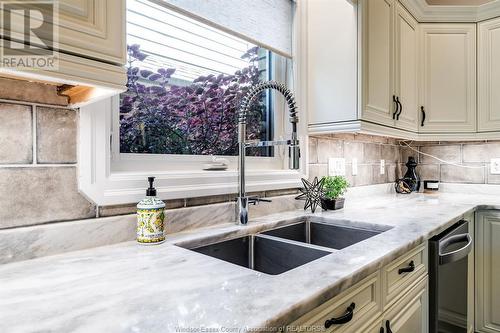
<box><xmin>394</xmin><ymin>3</ymin><xmax>419</xmax><ymax>132</ymax></box>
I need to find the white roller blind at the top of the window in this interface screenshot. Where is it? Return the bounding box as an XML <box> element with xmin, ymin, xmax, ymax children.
<box><xmin>154</xmin><ymin>0</ymin><xmax>295</xmax><ymax>57</ymax></box>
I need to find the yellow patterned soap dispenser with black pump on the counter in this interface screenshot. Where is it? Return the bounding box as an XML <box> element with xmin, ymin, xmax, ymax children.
<box><xmin>137</xmin><ymin>177</ymin><xmax>165</xmax><ymax>244</ymax></box>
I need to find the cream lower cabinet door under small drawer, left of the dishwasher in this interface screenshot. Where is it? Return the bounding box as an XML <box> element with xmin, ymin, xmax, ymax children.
<box><xmin>382</xmin><ymin>276</ymin><xmax>428</xmax><ymax>333</ymax></box>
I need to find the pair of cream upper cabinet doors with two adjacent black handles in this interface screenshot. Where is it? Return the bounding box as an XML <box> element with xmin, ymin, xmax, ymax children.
<box><xmin>361</xmin><ymin>0</ymin><xmax>418</xmax><ymax>132</ymax></box>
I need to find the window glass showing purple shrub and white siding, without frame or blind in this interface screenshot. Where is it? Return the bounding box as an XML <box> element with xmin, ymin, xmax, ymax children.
<box><xmin>119</xmin><ymin>0</ymin><xmax>290</xmax><ymax>157</ymax></box>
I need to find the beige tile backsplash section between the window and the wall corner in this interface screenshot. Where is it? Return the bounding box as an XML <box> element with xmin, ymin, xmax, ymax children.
<box><xmin>309</xmin><ymin>134</ymin><xmax>401</xmax><ymax>186</ymax></box>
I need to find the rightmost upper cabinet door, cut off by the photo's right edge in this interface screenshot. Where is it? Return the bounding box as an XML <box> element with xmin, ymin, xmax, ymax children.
<box><xmin>477</xmin><ymin>18</ymin><xmax>500</xmax><ymax>132</ymax></box>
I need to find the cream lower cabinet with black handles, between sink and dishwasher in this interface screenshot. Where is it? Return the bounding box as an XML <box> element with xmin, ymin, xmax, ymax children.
<box><xmin>290</xmin><ymin>245</ymin><xmax>428</xmax><ymax>333</ymax></box>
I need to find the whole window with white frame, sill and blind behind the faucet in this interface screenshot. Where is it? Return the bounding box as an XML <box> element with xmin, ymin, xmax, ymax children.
<box><xmin>78</xmin><ymin>0</ymin><xmax>307</xmax><ymax>205</ymax></box>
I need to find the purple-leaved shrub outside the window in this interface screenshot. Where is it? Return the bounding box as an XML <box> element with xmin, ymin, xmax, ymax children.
<box><xmin>120</xmin><ymin>44</ymin><xmax>267</xmax><ymax>156</ymax></box>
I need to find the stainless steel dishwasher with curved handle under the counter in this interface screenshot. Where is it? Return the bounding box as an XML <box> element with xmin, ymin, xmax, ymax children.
<box><xmin>429</xmin><ymin>220</ymin><xmax>474</xmax><ymax>333</ymax></box>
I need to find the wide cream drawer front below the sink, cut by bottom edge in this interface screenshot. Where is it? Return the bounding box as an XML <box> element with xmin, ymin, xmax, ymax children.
<box><xmin>291</xmin><ymin>272</ymin><xmax>382</xmax><ymax>333</ymax></box>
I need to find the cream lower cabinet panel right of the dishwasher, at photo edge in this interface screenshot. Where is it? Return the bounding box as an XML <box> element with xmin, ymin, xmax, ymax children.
<box><xmin>475</xmin><ymin>210</ymin><xmax>500</xmax><ymax>333</ymax></box>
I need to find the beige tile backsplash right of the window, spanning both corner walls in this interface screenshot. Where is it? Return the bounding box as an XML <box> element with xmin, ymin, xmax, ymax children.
<box><xmin>309</xmin><ymin>134</ymin><xmax>500</xmax><ymax>186</ymax></box>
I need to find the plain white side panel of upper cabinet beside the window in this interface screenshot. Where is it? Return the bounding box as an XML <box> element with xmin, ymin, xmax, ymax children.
<box><xmin>304</xmin><ymin>0</ymin><xmax>358</xmax><ymax>124</ymax></box>
